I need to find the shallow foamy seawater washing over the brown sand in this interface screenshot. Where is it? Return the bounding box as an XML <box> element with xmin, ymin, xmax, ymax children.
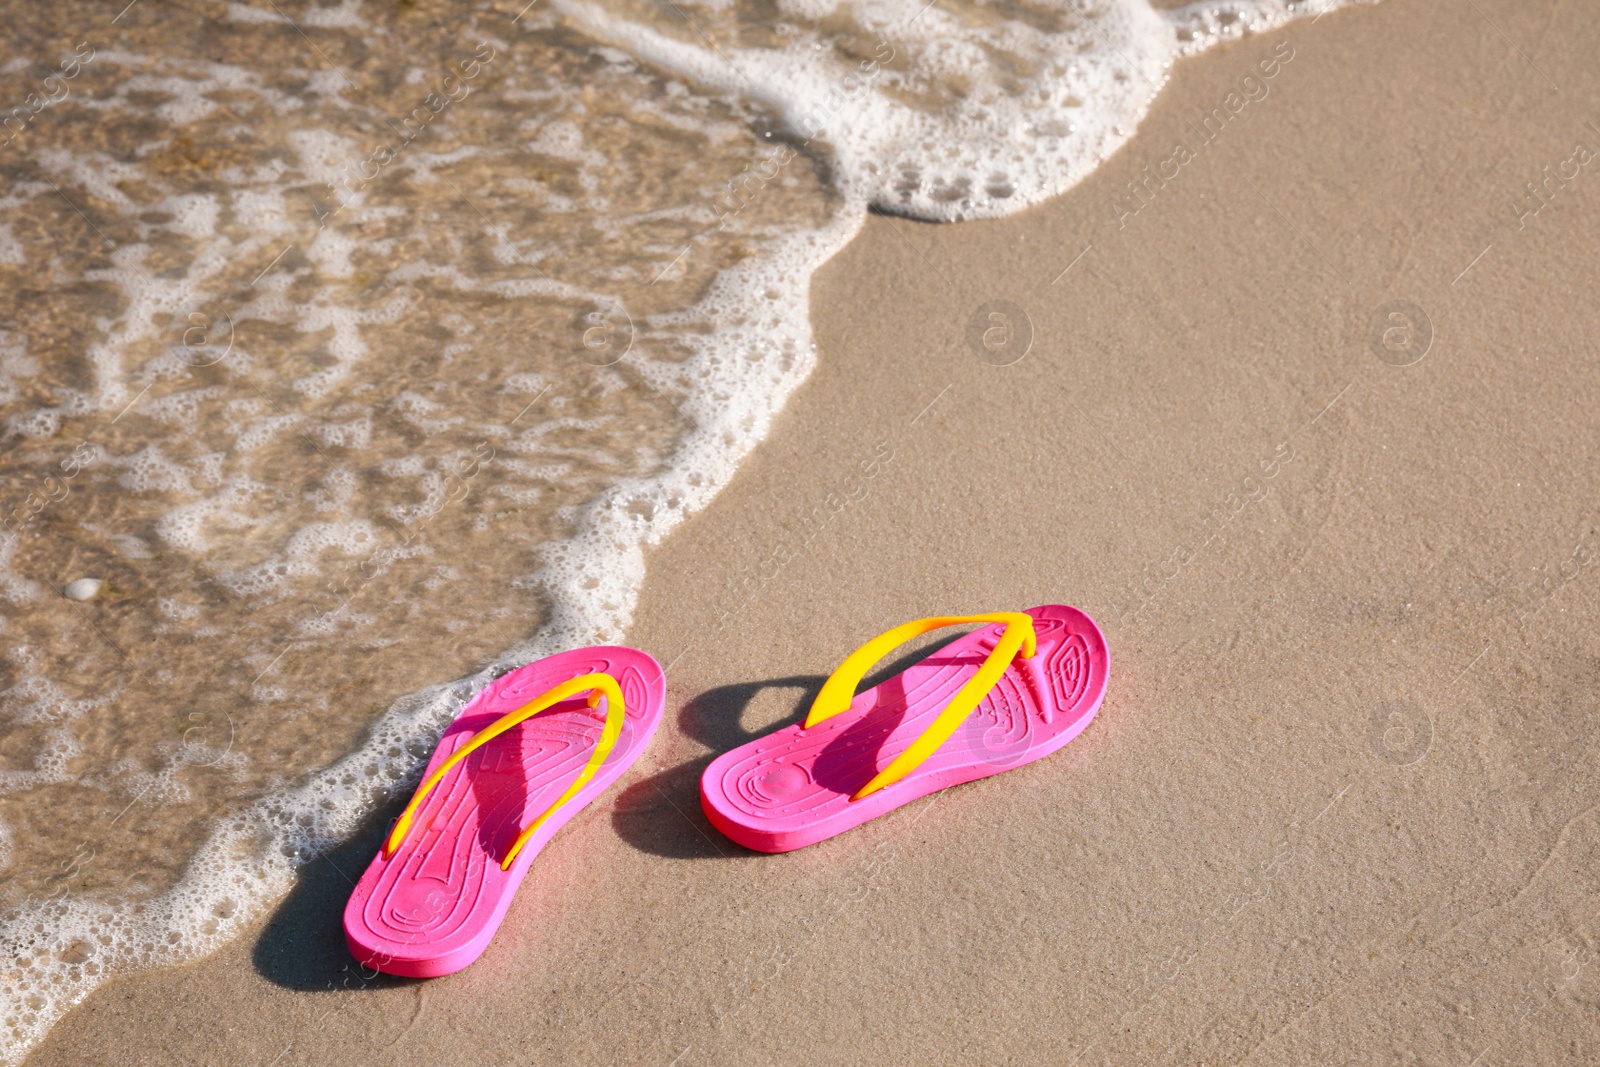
<box><xmin>0</xmin><ymin>0</ymin><xmax>1363</xmax><ymax>1061</ymax></box>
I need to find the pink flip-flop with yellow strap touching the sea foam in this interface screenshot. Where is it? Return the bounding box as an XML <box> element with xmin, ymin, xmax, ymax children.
<box><xmin>344</xmin><ymin>645</ymin><xmax>666</xmax><ymax>977</ymax></box>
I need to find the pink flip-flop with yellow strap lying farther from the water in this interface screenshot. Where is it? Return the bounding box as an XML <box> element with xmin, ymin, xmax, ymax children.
<box><xmin>701</xmin><ymin>605</ymin><xmax>1110</xmax><ymax>853</ymax></box>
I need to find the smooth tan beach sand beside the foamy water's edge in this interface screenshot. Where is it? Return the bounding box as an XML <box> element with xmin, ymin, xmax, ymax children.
<box><xmin>32</xmin><ymin>0</ymin><xmax>1600</xmax><ymax>1067</ymax></box>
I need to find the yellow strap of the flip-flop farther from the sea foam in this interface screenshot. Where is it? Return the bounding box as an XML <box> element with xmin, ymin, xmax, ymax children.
<box><xmin>805</xmin><ymin>611</ymin><xmax>1038</xmax><ymax>800</ymax></box>
